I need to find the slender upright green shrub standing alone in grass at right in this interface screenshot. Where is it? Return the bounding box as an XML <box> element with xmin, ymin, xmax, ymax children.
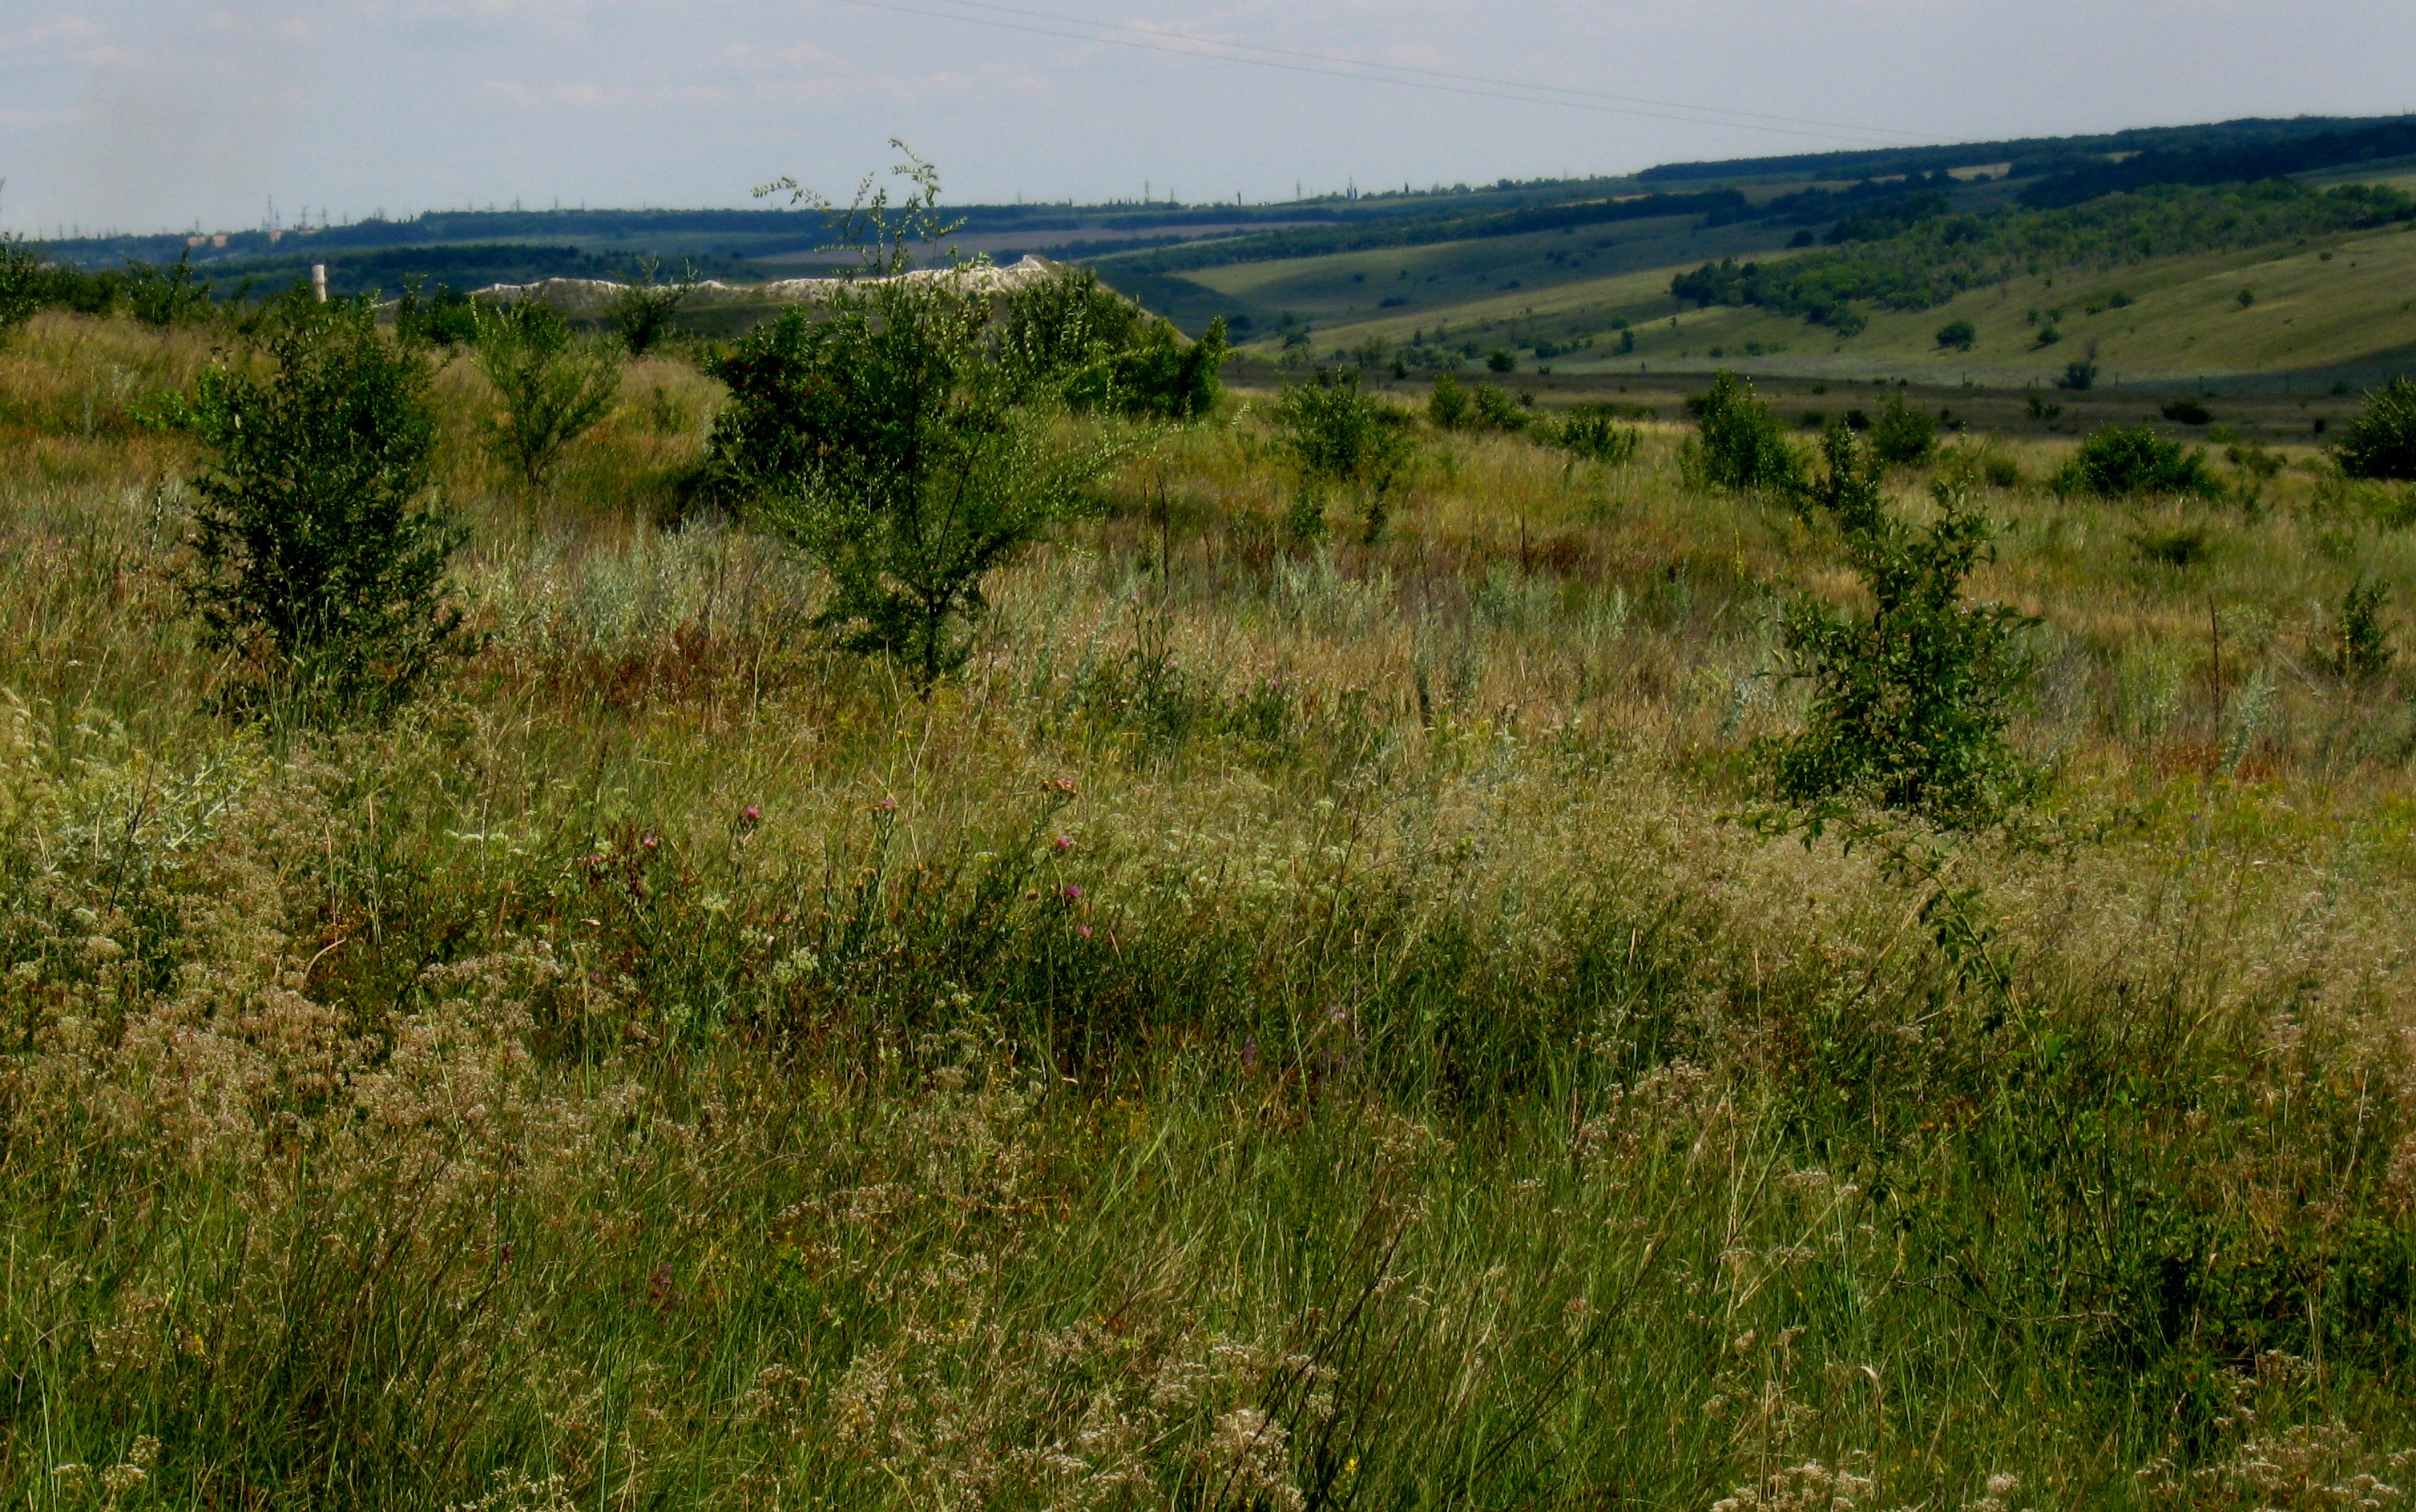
<box><xmin>1764</xmin><ymin>425</ymin><xmax>2037</xmax><ymax>826</ymax></box>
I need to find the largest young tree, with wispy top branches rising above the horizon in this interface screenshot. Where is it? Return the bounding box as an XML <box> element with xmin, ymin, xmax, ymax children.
<box><xmin>710</xmin><ymin>145</ymin><xmax>1131</xmax><ymax>691</ymax></box>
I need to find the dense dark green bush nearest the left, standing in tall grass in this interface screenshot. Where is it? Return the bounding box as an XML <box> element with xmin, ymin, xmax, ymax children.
<box><xmin>181</xmin><ymin>295</ymin><xmax>471</xmax><ymax>705</ymax></box>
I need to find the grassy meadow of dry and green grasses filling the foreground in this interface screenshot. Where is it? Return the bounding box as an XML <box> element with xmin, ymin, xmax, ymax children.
<box><xmin>0</xmin><ymin>300</ymin><xmax>2416</xmax><ymax>1512</ymax></box>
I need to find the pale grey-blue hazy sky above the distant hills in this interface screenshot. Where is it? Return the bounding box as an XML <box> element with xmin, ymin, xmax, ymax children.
<box><xmin>0</xmin><ymin>0</ymin><xmax>2416</xmax><ymax>234</ymax></box>
